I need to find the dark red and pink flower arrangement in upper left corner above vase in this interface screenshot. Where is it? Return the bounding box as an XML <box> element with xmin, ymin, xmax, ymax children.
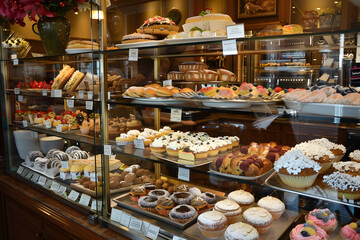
<box><xmin>0</xmin><ymin>0</ymin><xmax>88</xmax><ymax>26</ymax></box>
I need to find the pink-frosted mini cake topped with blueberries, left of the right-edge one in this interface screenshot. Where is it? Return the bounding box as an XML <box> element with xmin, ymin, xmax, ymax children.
<box><xmin>305</xmin><ymin>208</ymin><xmax>337</xmax><ymax>233</ymax></box>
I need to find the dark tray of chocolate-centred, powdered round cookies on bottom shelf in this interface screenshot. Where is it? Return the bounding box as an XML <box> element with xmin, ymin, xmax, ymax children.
<box><xmin>113</xmin><ymin>185</ymin><xmax>225</xmax><ymax>229</ymax></box>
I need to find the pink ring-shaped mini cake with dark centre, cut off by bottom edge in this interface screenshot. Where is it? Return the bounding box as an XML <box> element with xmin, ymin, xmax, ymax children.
<box><xmin>290</xmin><ymin>221</ymin><xmax>327</xmax><ymax>240</ymax></box>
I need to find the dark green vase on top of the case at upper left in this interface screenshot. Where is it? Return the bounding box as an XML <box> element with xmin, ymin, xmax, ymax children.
<box><xmin>33</xmin><ymin>16</ymin><xmax>70</xmax><ymax>56</ymax></box>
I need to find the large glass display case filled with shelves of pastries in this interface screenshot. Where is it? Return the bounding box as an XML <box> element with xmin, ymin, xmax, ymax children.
<box><xmin>2</xmin><ymin>31</ymin><xmax>360</xmax><ymax>239</ymax></box>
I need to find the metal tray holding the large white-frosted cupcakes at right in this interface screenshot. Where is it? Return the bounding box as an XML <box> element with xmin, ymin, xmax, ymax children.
<box><xmin>265</xmin><ymin>172</ymin><xmax>360</xmax><ymax>207</ymax></box>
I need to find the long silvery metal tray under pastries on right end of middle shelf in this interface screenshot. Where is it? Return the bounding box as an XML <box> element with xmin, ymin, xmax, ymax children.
<box><xmin>284</xmin><ymin>100</ymin><xmax>360</xmax><ymax>118</ymax></box>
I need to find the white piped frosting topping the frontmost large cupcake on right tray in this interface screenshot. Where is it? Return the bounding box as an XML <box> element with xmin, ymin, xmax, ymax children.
<box><xmin>274</xmin><ymin>150</ymin><xmax>321</xmax><ymax>175</ymax></box>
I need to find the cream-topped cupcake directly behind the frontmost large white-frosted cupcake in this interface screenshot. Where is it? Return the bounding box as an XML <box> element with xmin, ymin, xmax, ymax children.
<box><xmin>293</xmin><ymin>142</ymin><xmax>335</xmax><ymax>174</ymax></box>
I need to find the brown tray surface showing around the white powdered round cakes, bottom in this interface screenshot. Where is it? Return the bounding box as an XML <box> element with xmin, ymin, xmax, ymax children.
<box><xmin>184</xmin><ymin>210</ymin><xmax>299</xmax><ymax>240</ymax></box>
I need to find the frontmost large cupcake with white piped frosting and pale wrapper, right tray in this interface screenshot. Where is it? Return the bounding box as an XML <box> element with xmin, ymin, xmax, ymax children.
<box><xmin>274</xmin><ymin>150</ymin><xmax>321</xmax><ymax>188</ymax></box>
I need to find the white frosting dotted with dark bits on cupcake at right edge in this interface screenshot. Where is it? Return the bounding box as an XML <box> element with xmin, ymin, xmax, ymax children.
<box><xmin>323</xmin><ymin>172</ymin><xmax>360</xmax><ymax>191</ymax></box>
